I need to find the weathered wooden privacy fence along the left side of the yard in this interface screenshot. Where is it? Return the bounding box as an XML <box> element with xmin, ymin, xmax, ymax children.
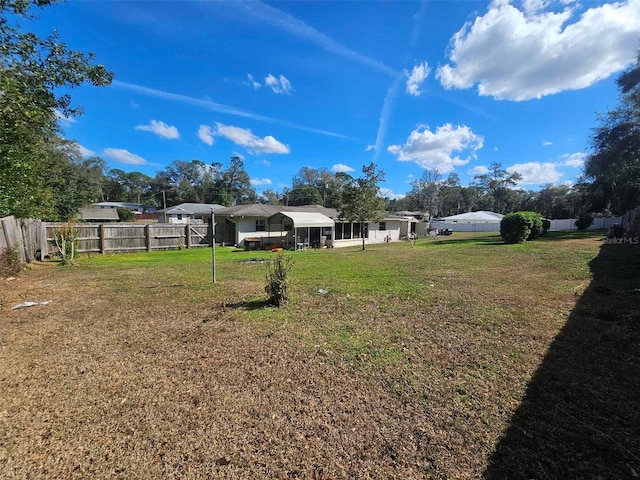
<box><xmin>0</xmin><ymin>216</ymin><xmax>211</xmax><ymax>262</ymax></box>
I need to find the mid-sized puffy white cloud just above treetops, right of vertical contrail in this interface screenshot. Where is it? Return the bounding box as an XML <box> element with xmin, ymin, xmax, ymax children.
<box><xmin>387</xmin><ymin>123</ymin><xmax>484</xmax><ymax>173</ymax></box>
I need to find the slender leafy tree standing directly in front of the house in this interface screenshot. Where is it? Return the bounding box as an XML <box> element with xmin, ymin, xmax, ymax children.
<box><xmin>339</xmin><ymin>162</ymin><xmax>385</xmax><ymax>250</ymax></box>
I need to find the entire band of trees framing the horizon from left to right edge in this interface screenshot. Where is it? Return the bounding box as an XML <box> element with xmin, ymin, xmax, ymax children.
<box><xmin>0</xmin><ymin>0</ymin><xmax>640</xmax><ymax>221</ymax></box>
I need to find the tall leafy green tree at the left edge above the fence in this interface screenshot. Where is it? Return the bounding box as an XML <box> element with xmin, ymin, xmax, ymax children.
<box><xmin>0</xmin><ymin>0</ymin><xmax>113</xmax><ymax>217</ymax></box>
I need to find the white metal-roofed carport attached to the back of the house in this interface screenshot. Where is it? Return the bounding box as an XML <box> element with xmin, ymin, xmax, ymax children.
<box><xmin>267</xmin><ymin>212</ymin><xmax>335</xmax><ymax>250</ymax></box>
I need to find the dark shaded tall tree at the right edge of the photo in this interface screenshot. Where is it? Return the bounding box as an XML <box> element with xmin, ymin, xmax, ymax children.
<box><xmin>584</xmin><ymin>53</ymin><xmax>640</xmax><ymax>214</ymax></box>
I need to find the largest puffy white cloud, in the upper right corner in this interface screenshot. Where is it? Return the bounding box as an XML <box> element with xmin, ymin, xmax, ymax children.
<box><xmin>436</xmin><ymin>0</ymin><xmax>640</xmax><ymax>101</ymax></box>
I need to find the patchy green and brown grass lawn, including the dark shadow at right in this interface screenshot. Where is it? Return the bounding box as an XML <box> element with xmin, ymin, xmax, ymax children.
<box><xmin>0</xmin><ymin>232</ymin><xmax>640</xmax><ymax>479</ymax></box>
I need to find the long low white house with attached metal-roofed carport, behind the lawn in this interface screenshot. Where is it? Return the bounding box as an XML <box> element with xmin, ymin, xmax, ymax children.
<box><xmin>214</xmin><ymin>204</ymin><xmax>418</xmax><ymax>249</ymax></box>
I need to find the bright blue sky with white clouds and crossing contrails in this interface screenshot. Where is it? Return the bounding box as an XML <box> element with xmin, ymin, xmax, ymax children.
<box><xmin>38</xmin><ymin>0</ymin><xmax>640</xmax><ymax>197</ymax></box>
